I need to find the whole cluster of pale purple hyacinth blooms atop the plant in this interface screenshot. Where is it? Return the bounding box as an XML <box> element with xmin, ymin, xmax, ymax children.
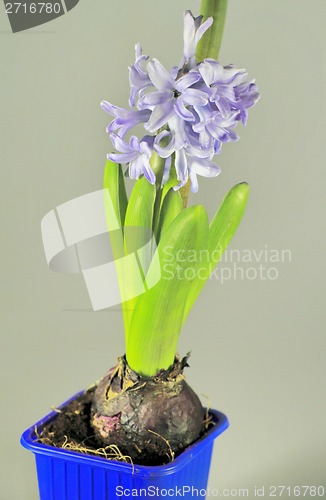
<box><xmin>101</xmin><ymin>11</ymin><xmax>259</xmax><ymax>192</ymax></box>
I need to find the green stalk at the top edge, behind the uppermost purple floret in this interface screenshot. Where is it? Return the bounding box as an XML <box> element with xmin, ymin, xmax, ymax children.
<box><xmin>196</xmin><ymin>0</ymin><xmax>227</xmax><ymax>62</ymax></box>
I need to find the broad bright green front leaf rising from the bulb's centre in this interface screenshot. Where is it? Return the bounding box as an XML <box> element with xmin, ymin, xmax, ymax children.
<box><xmin>127</xmin><ymin>205</ymin><xmax>208</xmax><ymax>376</ymax></box>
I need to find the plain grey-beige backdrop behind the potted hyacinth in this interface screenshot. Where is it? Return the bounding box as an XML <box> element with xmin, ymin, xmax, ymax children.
<box><xmin>0</xmin><ymin>0</ymin><xmax>326</xmax><ymax>500</ymax></box>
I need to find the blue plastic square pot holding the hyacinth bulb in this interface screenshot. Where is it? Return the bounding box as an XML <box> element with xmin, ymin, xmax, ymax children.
<box><xmin>21</xmin><ymin>394</ymin><xmax>229</xmax><ymax>500</ymax></box>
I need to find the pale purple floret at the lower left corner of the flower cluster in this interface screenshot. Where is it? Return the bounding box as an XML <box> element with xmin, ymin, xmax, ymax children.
<box><xmin>107</xmin><ymin>134</ymin><xmax>156</xmax><ymax>184</ymax></box>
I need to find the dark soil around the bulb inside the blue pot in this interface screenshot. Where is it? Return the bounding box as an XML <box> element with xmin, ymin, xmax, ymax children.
<box><xmin>35</xmin><ymin>388</ymin><xmax>213</xmax><ymax>465</ymax></box>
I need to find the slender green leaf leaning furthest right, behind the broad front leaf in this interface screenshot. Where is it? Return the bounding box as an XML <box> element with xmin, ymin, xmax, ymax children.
<box><xmin>184</xmin><ymin>182</ymin><xmax>249</xmax><ymax>320</ymax></box>
